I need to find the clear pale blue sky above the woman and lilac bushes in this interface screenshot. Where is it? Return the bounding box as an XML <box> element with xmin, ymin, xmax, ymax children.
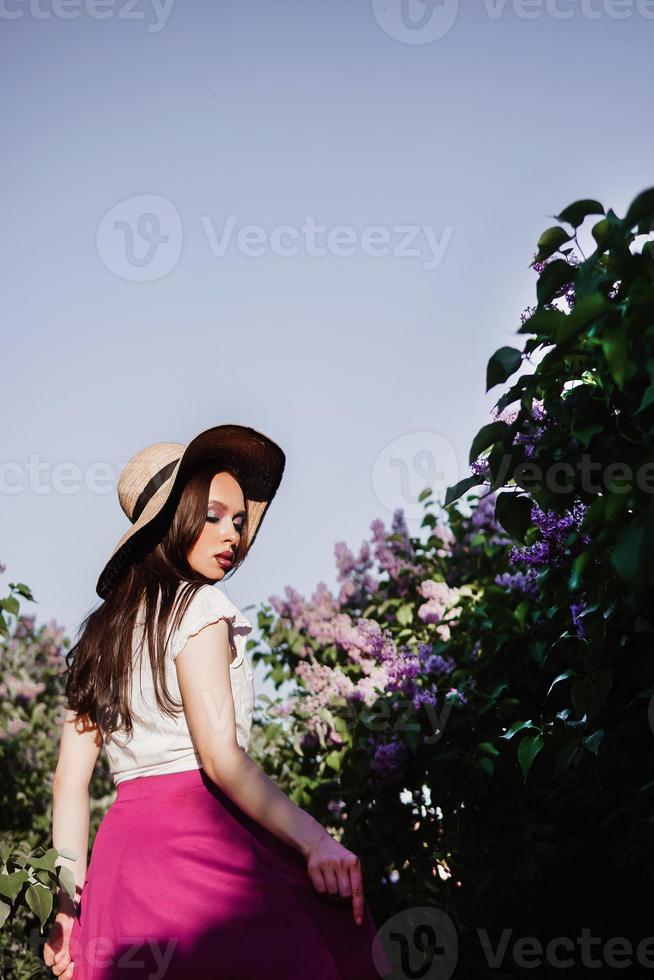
<box><xmin>0</xmin><ymin>0</ymin><xmax>654</xmax><ymax>696</ymax></box>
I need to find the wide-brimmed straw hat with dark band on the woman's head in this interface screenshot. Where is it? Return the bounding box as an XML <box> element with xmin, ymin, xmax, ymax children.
<box><xmin>96</xmin><ymin>425</ymin><xmax>286</xmax><ymax>599</ymax></box>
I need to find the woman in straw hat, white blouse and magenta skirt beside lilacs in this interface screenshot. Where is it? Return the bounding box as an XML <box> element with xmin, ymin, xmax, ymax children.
<box><xmin>44</xmin><ymin>425</ymin><xmax>388</xmax><ymax>980</ymax></box>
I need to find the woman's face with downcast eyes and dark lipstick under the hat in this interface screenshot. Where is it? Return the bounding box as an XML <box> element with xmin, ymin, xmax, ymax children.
<box><xmin>188</xmin><ymin>473</ymin><xmax>245</xmax><ymax>579</ymax></box>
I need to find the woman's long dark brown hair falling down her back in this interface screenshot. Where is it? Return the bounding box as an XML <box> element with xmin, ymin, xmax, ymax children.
<box><xmin>65</xmin><ymin>462</ymin><xmax>248</xmax><ymax>735</ymax></box>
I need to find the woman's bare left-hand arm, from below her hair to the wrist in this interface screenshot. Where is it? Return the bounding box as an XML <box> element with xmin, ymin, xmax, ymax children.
<box><xmin>52</xmin><ymin>709</ymin><xmax>102</xmax><ymax>915</ymax></box>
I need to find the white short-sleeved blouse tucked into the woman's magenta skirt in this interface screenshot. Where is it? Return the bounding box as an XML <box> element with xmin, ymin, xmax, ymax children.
<box><xmin>104</xmin><ymin>585</ymin><xmax>254</xmax><ymax>786</ymax></box>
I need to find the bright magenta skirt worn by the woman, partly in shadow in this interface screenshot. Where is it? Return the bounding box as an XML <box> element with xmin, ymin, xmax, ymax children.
<box><xmin>70</xmin><ymin>769</ymin><xmax>390</xmax><ymax>980</ymax></box>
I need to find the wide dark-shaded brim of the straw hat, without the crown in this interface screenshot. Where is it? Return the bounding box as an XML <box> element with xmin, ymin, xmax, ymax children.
<box><xmin>96</xmin><ymin>424</ymin><xmax>286</xmax><ymax>599</ymax></box>
